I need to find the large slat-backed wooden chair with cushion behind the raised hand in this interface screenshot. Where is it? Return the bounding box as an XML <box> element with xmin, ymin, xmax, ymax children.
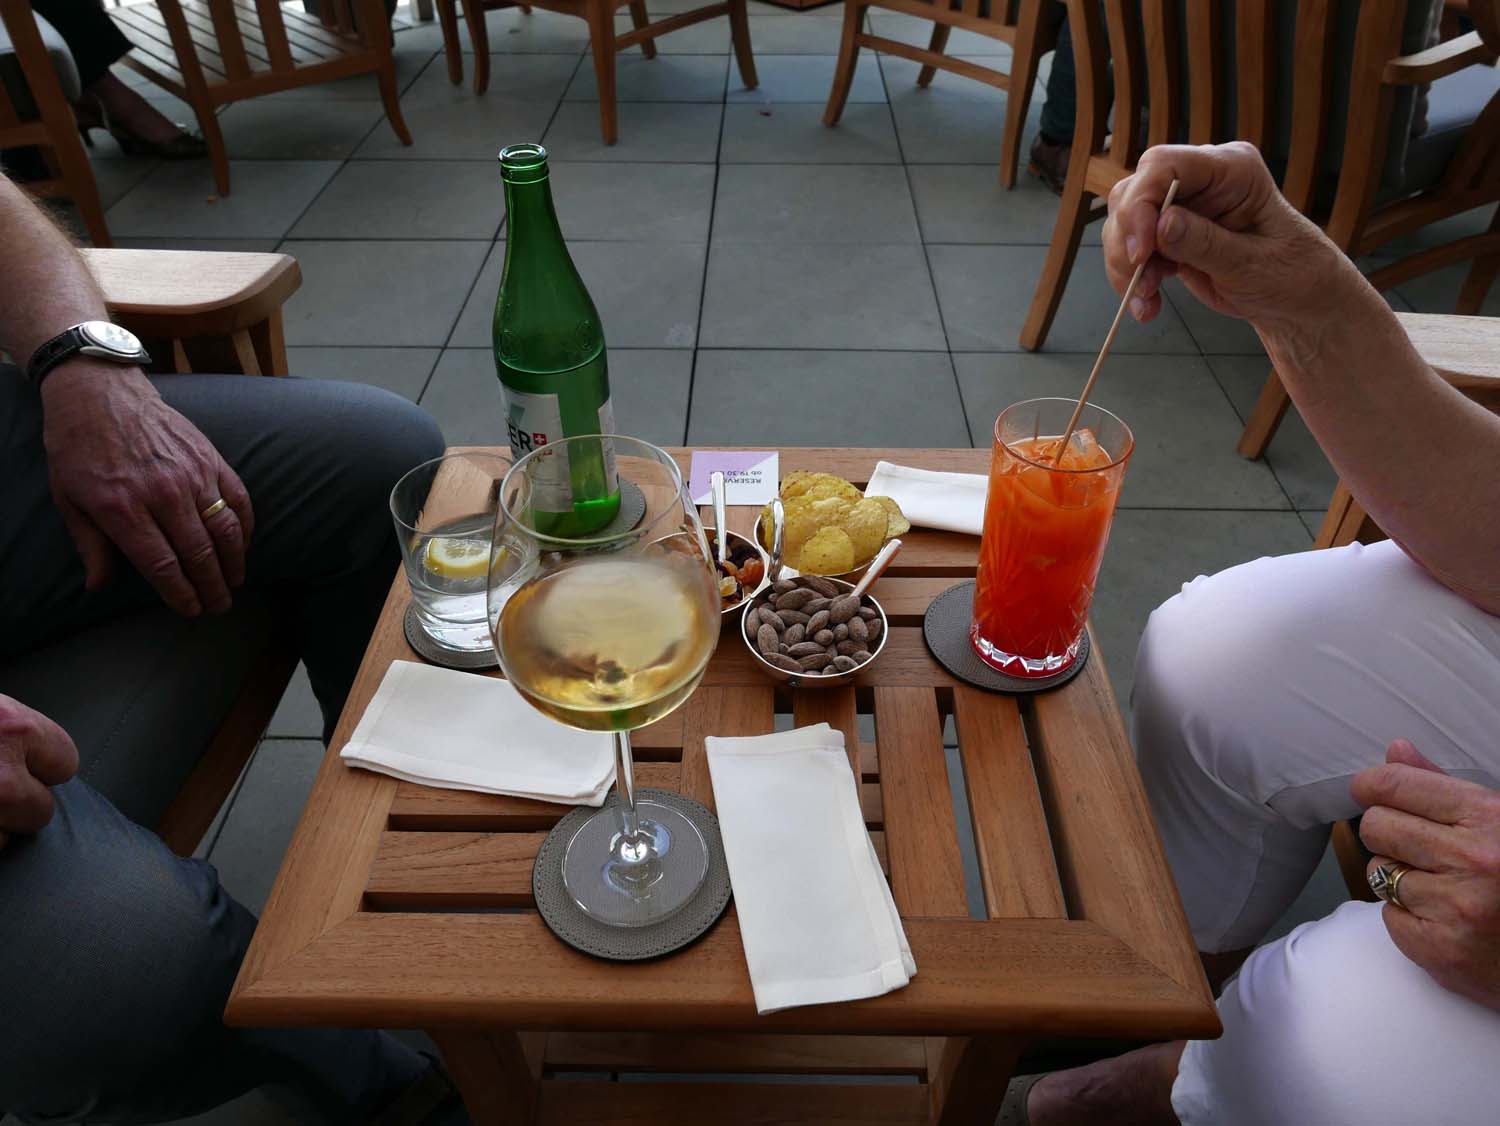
<box><xmin>1022</xmin><ymin>0</ymin><xmax>1500</xmax><ymax>401</ymax></box>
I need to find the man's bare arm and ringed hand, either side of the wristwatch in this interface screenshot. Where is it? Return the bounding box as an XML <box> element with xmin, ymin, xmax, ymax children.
<box><xmin>0</xmin><ymin>175</ymin><xmax>254</xmax><ymax>615</ymax></box>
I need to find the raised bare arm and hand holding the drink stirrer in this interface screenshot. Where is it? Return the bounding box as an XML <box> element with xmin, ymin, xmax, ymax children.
<box><xmin>1104</xmin><ymin>144</ymin><xmax>1500</xmax><ymax>613</ymax></box>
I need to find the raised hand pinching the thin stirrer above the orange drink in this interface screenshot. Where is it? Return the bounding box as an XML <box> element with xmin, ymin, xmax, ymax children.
<box><xmin>1104</xmin><ymin>141</ymin><xmax>1358</xmax><ymax>333</ymax></box>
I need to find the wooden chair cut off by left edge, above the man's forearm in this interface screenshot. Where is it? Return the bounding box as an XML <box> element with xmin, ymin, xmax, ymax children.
<box><xmin>0</xmin><ymin>0</ymin><xmax>111</xmax><ymax>246</ymax></box>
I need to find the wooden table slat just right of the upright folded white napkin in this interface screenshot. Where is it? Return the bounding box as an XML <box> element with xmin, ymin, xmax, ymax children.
<box><xmin>875</xmin><ymin>688</ymin><xmax>969</xmax><ymax>916</ymax></box>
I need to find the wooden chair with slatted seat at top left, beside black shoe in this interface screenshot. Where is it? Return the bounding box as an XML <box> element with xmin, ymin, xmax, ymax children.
<box><xmin>110</xmin><ymin>0</ymin><xmax>411</xmax><ymax>195</ymax></box>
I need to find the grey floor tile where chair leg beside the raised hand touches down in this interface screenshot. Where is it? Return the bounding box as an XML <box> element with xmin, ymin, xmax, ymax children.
<box><xmin>927</xmin><ymin>246</ymin><xmax>1199</xmax><ymax>355</ymax></box>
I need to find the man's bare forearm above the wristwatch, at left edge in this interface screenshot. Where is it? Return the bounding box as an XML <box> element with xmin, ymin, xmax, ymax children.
<box><xmin>0</xmin><ymin>175</ymin><xmax>108</xmax><ymax>367</ymax></box>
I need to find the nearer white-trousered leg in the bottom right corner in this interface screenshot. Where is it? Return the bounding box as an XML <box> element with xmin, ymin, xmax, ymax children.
<box><xmin>1172</xmin><ymin>903</ymin><xmax>1500</xmax><ymax>1126</ymax></box>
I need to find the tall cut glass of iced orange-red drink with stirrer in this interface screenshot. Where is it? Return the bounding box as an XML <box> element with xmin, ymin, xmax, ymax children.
<box><xmin>969</xmin><ymin>399</ymin><xmax>1136</xmax><ymax>676</ymax></box>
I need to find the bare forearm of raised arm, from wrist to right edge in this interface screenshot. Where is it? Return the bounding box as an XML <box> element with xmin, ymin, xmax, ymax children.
<box><xmin>1262</xmin><ymin>266</ymin><xmax>1500</xmax><ymax>613</ymax></box>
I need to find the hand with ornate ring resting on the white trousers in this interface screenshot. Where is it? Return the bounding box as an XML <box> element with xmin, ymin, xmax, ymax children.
<box><xmin>1350</xmin><ymin>739</ymin><xmax>1500</xmax><ymax>1011</ymax></box>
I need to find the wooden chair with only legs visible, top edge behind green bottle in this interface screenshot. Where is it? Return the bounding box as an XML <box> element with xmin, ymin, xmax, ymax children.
<box><xmin>437</xmin><ymin>0</ymin><xmax>759</xmax><ymax>144</ymax></box>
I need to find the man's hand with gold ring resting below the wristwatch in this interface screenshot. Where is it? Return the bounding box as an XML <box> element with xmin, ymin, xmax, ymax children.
<box><xmin>42</xmin><ymin>357</ymin><xmax>255</xmax><ymax>618</ymax></box>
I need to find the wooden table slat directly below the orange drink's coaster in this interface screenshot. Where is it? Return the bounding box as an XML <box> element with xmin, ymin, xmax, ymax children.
<box><xmin>954</xmin><ymin>687</ymin><xmax>1068</xmax><ymax>919</ymax></box>
